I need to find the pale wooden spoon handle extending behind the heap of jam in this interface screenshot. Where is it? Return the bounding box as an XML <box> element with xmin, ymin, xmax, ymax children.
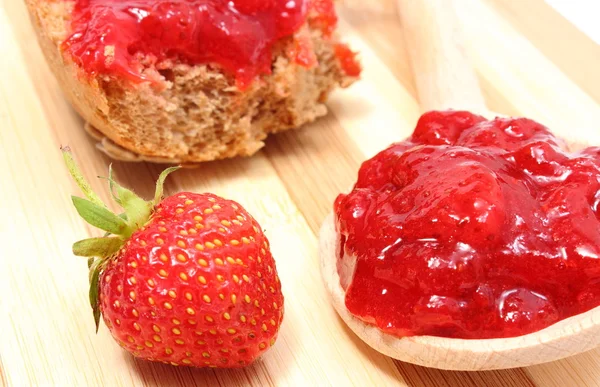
<box><xmin>397</xmin><ymin>0</ymin><xmax>487</xmax><ymax>113</ymax></box>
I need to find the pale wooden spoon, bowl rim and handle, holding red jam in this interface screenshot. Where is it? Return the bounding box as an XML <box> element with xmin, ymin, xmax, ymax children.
<box><xmin>320</xmin><ymin>0</ymin><xmax>600</xmax><ymax>371</ymax></box>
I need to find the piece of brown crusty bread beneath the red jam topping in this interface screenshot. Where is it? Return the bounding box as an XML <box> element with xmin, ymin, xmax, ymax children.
<box><xmin>26</xmin><ymin>0</ymin><xmax>356</xmax><ymax>163</ymax></box>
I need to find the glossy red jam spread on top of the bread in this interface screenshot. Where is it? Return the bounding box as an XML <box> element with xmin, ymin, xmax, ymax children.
<box><xmin>62</xmin><ymin>0</ymin><xmax>352</xmax><ymax>88</ymax></box>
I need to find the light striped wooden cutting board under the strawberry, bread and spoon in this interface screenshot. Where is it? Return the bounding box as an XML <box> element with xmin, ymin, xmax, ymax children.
<box><xmin>0</xmin><ymin>0</ymin><xmax>600</xmax><ymax>387</ymax></box>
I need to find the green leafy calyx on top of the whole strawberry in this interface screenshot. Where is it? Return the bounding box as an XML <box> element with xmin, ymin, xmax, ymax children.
<box><xmin>61</xmin><ymin>147</ymin><xmax>181</xmax><ymax>332</ymax></box>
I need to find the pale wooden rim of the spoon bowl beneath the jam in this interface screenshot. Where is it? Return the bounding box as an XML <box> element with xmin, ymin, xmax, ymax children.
<box><xmin>319</xmin><ymin>214</ymin><xmax>600</xmax><ymax>371</ymax></box>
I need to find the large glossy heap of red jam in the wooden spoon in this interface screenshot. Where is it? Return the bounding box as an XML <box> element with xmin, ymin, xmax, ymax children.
<box><xmin>335</xmin><ymin>111</ymin><xmax>600</xmax><ymax>339</ymax></box>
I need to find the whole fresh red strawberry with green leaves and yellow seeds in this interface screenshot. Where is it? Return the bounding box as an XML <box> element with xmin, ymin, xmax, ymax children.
<box><xmin>63</xmin><ymin>149</ymin><xmax>283</xmax><ymax>368</ymax></box>
